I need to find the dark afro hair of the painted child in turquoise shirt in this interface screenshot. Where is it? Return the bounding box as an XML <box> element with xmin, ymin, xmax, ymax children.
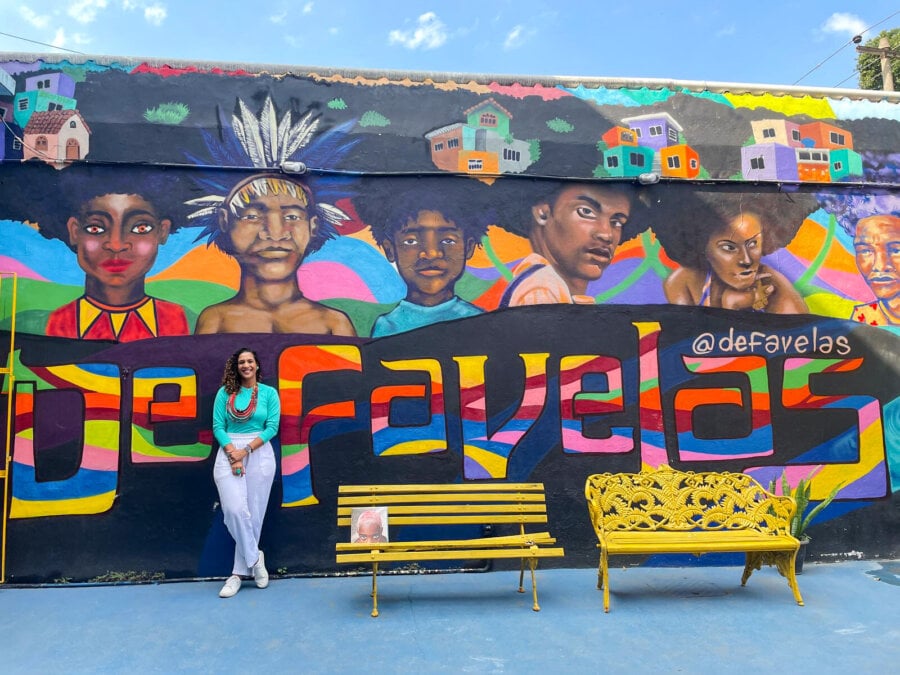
<box><xmin>354</xmin><ymin>176</ymin><xmax>496</xmax><ymax>245</ymax></box>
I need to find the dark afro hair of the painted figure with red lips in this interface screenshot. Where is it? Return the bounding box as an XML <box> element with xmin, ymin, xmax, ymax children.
<box><xmin>0</xmin><ymin>161</ymin><xmax>196</xmax><ymax>250</ymax></box>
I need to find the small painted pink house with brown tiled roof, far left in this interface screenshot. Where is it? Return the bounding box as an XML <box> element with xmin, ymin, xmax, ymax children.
<box><xmin>22</xmin><ymin>110</ymin><xmax>91</xmax><ymax>165</ymax></box>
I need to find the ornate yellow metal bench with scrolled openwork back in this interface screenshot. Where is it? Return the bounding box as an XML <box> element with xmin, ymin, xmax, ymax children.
<box><xmin>584</xmin><ymin>466</ymin><xmax>803</xmax><ymax>612</ymax></box>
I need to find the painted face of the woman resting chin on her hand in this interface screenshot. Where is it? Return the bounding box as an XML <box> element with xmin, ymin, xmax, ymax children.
<box><xmin>706</xmin><ymin>213</ymin><xmax>763</xmax><ymax>291</ymax></box>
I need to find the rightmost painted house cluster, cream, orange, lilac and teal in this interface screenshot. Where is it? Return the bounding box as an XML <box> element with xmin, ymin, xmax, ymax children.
<box><xmin>741</xmin><ymin>119</ymin><xmax>862</xmax><ymax>182</ymax></box>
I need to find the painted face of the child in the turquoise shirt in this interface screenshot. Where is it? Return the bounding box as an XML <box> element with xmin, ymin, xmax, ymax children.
<box><xmin>381</xmin><ymin>211</ymin><xmax>475</xmax><ymax>307</ymax></box>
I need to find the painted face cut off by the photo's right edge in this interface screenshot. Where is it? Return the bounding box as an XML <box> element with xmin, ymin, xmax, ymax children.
<box><xmin>853</xmin><ymin>215</ymin><xmax>900</xmax><ymax>300</ymax></box>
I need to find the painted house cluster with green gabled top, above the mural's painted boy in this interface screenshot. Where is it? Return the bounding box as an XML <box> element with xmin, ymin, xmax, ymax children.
<box><xmin>425</xmin><ymin>98</ymin><xmax>534</xmax><ymax>174</ymax></box>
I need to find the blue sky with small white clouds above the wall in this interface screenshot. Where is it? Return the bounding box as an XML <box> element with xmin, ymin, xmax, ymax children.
<box><xmin>0</xmin><ymin>0</ymin><xmax>900</xmax><ymax>88</ymax></box>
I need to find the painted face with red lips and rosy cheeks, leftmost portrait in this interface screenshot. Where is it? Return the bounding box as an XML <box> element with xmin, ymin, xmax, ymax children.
<box><xmin>66</xmin><ymin>194</ymin><xmax>172</xmax><ymax>300</ymax></box>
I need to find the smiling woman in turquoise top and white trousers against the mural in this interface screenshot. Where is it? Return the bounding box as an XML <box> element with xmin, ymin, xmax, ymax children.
<box><xmin>213</xmin><ymin>348</ymin><xmax>281</xmax><ymax>598</ymax></box>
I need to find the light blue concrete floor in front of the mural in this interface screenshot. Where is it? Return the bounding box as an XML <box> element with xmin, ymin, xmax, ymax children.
<box><xmin>0</xmin><ymin>561</ymin><xmax>900</xmax><ymax>675</ymax></box>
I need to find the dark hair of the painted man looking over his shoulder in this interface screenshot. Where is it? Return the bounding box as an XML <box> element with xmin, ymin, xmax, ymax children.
<box><xmin>491</xmin><ymin>177</ymin><xmax>650</xmax><ymax>242</ymax></box>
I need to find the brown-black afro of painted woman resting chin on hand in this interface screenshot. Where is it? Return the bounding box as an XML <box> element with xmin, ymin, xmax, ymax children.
<box><xmin>653</xmin><ymin>185</ymin><xmax>818</xmax><ymax>270</ymax></box>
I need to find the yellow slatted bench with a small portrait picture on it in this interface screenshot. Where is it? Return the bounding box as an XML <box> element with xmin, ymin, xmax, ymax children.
<box><xmin>337</xmin><ymin>483</ymin><xmax>564</xmax><ymax>616</ymax></box>
